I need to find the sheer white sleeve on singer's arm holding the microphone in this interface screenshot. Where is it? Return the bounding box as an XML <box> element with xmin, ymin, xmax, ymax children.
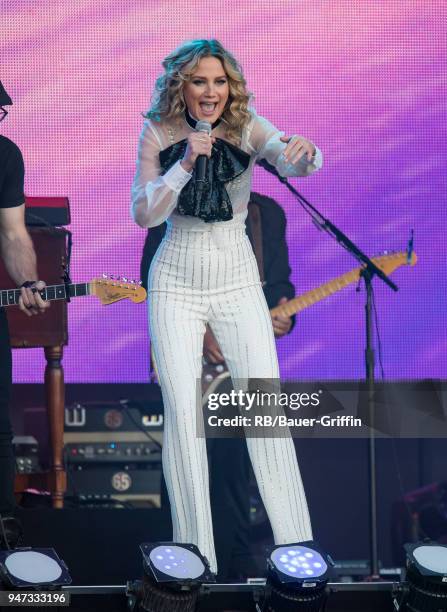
<box><xmin>131</xmin><ymin>121</ymin><xmax>191</xmax><ymax>227</ymax></box>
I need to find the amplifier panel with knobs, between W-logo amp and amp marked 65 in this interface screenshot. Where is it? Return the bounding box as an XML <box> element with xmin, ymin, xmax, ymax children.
<box><xmin>65</xmin><ymin>436</ymin><xmax>161</xmax><ymax>465</ymax></box>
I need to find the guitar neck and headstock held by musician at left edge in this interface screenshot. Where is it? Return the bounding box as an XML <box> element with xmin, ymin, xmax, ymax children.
<box><xmin>0</xmin><ymin>276</ymin><xmax>146</xmax><ymax>306</ymax></box>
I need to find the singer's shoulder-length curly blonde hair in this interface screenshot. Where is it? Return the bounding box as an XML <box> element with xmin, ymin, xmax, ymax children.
<box><xmin>144</xmin><ymin>39</ymin><xmax>251</xmax><ymax>145</ymax></box>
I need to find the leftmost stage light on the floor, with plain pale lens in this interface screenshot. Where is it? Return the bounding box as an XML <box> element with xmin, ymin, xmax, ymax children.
<box><xmin>0</xmin><ymin>548</ymin><xmax>71</xmax><ymax>589</ymax></box>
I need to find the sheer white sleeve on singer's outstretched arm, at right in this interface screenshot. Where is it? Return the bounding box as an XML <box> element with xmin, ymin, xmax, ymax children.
<box><xmin>248</xmin><ymin>114</ymin><xmax>323</xmax><ymax>176</ymax></box>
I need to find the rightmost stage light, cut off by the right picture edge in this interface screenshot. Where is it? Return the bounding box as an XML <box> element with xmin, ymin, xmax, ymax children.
<box><xmin>395</xmin><ymin>541</ymin><xmax>447</xmax><ymax>612</ymax></box>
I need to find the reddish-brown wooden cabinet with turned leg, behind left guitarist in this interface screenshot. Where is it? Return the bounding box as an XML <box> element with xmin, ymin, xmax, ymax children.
<box><xmin>0</xmin><ymin>228</ymin><xmax>68</xmax><ymax>508</ymax></box>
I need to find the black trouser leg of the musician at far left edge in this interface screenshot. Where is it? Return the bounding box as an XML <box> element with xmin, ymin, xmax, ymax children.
<box><xmin>0</xmin><ymin>308</ymin><xmax>16</xmax><ymax>515</ymax></box>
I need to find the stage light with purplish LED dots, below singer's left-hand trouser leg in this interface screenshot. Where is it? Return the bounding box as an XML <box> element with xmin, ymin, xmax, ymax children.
<box><xmin>140</xmin><ymin>542</ymin><xmax>216</xmax><ymax>612</ymax></box>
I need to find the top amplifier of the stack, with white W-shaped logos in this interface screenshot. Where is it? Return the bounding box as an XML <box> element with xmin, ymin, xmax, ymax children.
<box><xmin>64</xmin><ymin>400</ymin><xmax>163</xmax><ymax>434</ymax></box>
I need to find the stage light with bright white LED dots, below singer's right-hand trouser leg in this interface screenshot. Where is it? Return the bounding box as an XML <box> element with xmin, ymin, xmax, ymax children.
<box><xmin>264</xmin><ymin>541</ymin><xmax>334</xmax><ymax>612</ymax></box>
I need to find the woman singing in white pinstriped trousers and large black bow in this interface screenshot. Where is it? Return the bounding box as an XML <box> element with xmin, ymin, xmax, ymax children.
<box><xmin>132</xmin><ymin>40</ymin><xmax>322</xmax><ymax>572</ymax></box>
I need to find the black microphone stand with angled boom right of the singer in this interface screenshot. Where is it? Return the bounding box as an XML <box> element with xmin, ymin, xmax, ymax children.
<box><xmin>257</xmin><ymin>159</ymin><xmax>400</xmax><ymax>580</ymax></box>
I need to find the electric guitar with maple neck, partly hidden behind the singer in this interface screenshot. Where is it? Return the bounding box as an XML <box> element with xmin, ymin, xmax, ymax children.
<box><xmin>202</xmin><ymin>251</ymin><xmax>417</xmax><ymax>405</ymax></box>
